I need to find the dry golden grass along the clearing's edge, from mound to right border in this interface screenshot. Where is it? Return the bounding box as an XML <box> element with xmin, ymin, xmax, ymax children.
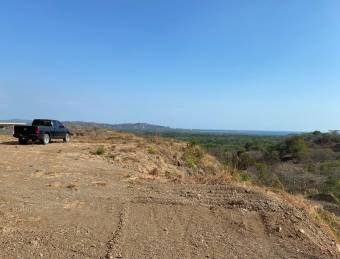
<box><xmin>68</xmin><ymin>129</ymin><xmax>340</xmax><ymax>243</ymax></box>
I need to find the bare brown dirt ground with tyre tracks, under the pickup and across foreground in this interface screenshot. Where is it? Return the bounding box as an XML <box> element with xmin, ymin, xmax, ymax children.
<box><xmin>0</xmin><ymin>137</ymin><xmax>340</xmax><ymax>258</ymax></box>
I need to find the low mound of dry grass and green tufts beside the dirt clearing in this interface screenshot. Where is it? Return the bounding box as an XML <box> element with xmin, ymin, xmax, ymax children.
<box><xmin>76</xmin><ymin>129</ymin><xmax>228</xmax><ymax>181</ymax></box>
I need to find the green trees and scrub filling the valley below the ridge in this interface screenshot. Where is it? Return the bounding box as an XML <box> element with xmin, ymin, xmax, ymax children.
<box><xmin>140</xmin><ymin>131</ymin><xmax>340</xmax><ymax>209</ymax></box>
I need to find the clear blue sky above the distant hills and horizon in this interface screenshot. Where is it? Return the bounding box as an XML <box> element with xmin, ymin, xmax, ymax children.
<box><xmin>0</xmin><ymin>0</ymin><xmax>340</xmax><ymax>130</ymax></box>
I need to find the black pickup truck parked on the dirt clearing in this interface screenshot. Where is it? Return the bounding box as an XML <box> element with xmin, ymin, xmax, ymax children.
<box><xmin>13</xmin><ymin>119</ymin><xmax>72</xmax><ymax>145</ymax></box>
